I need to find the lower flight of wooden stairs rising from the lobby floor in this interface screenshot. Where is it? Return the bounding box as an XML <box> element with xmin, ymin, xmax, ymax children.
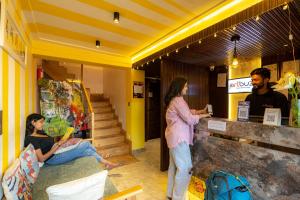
<box><xmin>90</xmin><ymin>94</ymin><xmax>131</xmax><ymax>156</ymax></box>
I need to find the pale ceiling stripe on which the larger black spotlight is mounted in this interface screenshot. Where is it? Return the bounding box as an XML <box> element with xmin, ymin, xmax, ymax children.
<box><xmin>43</xmin><ymin>0</ymin><xmax>159</xmax><ymax>36</ymax></box>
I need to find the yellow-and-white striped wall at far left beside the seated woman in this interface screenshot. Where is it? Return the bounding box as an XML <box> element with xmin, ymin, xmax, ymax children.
<box><xmin>0</xmin><ymin>1</ymin><xmax>37</xmax><ymax>176</ymax></box>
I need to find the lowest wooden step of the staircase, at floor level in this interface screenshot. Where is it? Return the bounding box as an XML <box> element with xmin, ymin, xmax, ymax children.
<box><xmin>96</xmin><ymin>143</ymin><xmax>130</xmax><ymax>156</ymax></box>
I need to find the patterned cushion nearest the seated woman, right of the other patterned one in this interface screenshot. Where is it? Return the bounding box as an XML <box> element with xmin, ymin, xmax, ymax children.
<box><xmin>19</xmin><ymin>144</ymin><xmax>40</xmax><ymax>184</ymax></box>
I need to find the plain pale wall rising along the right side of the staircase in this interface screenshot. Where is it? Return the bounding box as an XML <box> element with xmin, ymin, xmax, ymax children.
<box><xmin>103</xmin><ymin>68</ymin><xmax>127</xmax><ymax>130</ymax></box>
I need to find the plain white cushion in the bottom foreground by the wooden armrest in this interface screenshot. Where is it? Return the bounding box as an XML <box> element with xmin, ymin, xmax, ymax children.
<box><xmin>46</xmin><ymin>170</ymin><xmax>108</xmax><ymax>200</ymax></box>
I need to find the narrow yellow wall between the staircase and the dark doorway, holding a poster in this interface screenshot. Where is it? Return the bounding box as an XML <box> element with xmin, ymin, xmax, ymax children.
<box><xmin>126</xmin><ymin>69</ymin><xmax>145</xmax><ymax>150</ymax></box>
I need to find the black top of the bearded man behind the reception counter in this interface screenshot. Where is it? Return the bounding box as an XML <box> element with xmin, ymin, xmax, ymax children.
<box><xmin>245</xmin><ymin>89</ymin><xmax>289</xmax><ymax>117</ymax></box>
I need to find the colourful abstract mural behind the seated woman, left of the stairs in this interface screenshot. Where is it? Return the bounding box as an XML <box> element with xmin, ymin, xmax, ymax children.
<box><xmin>39</xmin><ymin>79</ymin><xmax>88</xmax><ymax>137</ymax></box>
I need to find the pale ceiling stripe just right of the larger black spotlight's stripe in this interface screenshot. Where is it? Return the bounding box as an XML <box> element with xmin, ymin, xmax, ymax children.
<box><xmin>106</xmin><ymin>0</ymin><xmax>175</xmax><ymax>26</ymax></box>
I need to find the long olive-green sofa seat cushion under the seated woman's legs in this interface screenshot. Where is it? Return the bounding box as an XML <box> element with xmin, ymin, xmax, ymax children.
<box><xmin>32</xmin><ymin>156</ymin><xmax>118</xmax><ymax>200</ymax></box>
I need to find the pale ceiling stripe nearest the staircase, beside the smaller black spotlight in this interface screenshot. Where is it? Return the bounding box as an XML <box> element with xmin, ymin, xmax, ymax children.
<box><xmin>24</xmin><ymin>11</ymin><xmax>140</xmax><ymax>46</ymax></box>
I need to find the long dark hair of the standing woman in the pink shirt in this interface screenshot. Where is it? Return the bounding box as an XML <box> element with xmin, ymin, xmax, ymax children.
<box><xmin>165</xmin><ymin>77</ymin><xmax>187</xmax><ymax>107</ymax></box>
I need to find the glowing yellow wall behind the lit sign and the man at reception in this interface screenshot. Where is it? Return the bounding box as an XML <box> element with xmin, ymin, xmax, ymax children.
<box><xmin>228</xmin><ymin>58</ymin><xmax>261</xmax><ymax>120</ymax></box>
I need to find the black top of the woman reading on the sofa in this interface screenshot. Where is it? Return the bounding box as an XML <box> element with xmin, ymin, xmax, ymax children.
<box><xmin>24</xmin><ymin>136</ymin><xmax>54</xmax><ymax>160</ymax></box>
